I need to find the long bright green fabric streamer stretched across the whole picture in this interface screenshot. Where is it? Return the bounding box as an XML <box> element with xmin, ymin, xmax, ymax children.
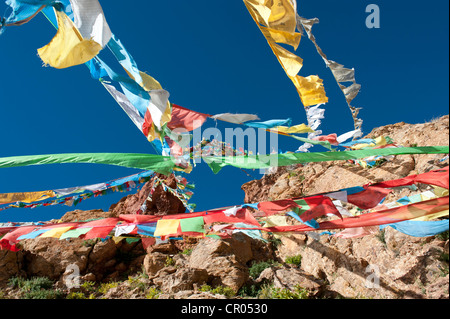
<box><xmin>0</xmin><ymin>146</ymin><xmax>449</xmax><ymax>175</ymax></box>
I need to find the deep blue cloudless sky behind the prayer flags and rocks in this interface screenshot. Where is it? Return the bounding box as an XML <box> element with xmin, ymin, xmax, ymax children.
<box><xmin>0</xmin><ymin>0</ymin><xmax>449</xmax><ymax>222</ymax></box>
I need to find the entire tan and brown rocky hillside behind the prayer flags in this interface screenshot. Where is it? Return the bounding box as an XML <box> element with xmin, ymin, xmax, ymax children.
<box><xmin>0</xmin><ymin>116</ymin><xmax>449</xmax><ymax>299</ymax></box>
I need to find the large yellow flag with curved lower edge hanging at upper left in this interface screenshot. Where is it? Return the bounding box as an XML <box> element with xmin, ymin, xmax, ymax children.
<box><xmin>38</xmin><ymin>10</ymin><xmax>102</xmax><ymax>69</ymax></box>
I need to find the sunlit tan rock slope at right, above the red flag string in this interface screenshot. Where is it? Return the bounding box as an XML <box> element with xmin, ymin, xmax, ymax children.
<box><xmin>242</xmin><ymin>115</ymin><xmax>449</xmax><ymax>203</ymax></box>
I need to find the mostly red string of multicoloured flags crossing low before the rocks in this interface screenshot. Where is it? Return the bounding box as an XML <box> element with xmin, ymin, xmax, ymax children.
<box><xmin>0</xmin><ymin>168</ymin><xmax>449</xmax><ymax>251</ymax></box>
